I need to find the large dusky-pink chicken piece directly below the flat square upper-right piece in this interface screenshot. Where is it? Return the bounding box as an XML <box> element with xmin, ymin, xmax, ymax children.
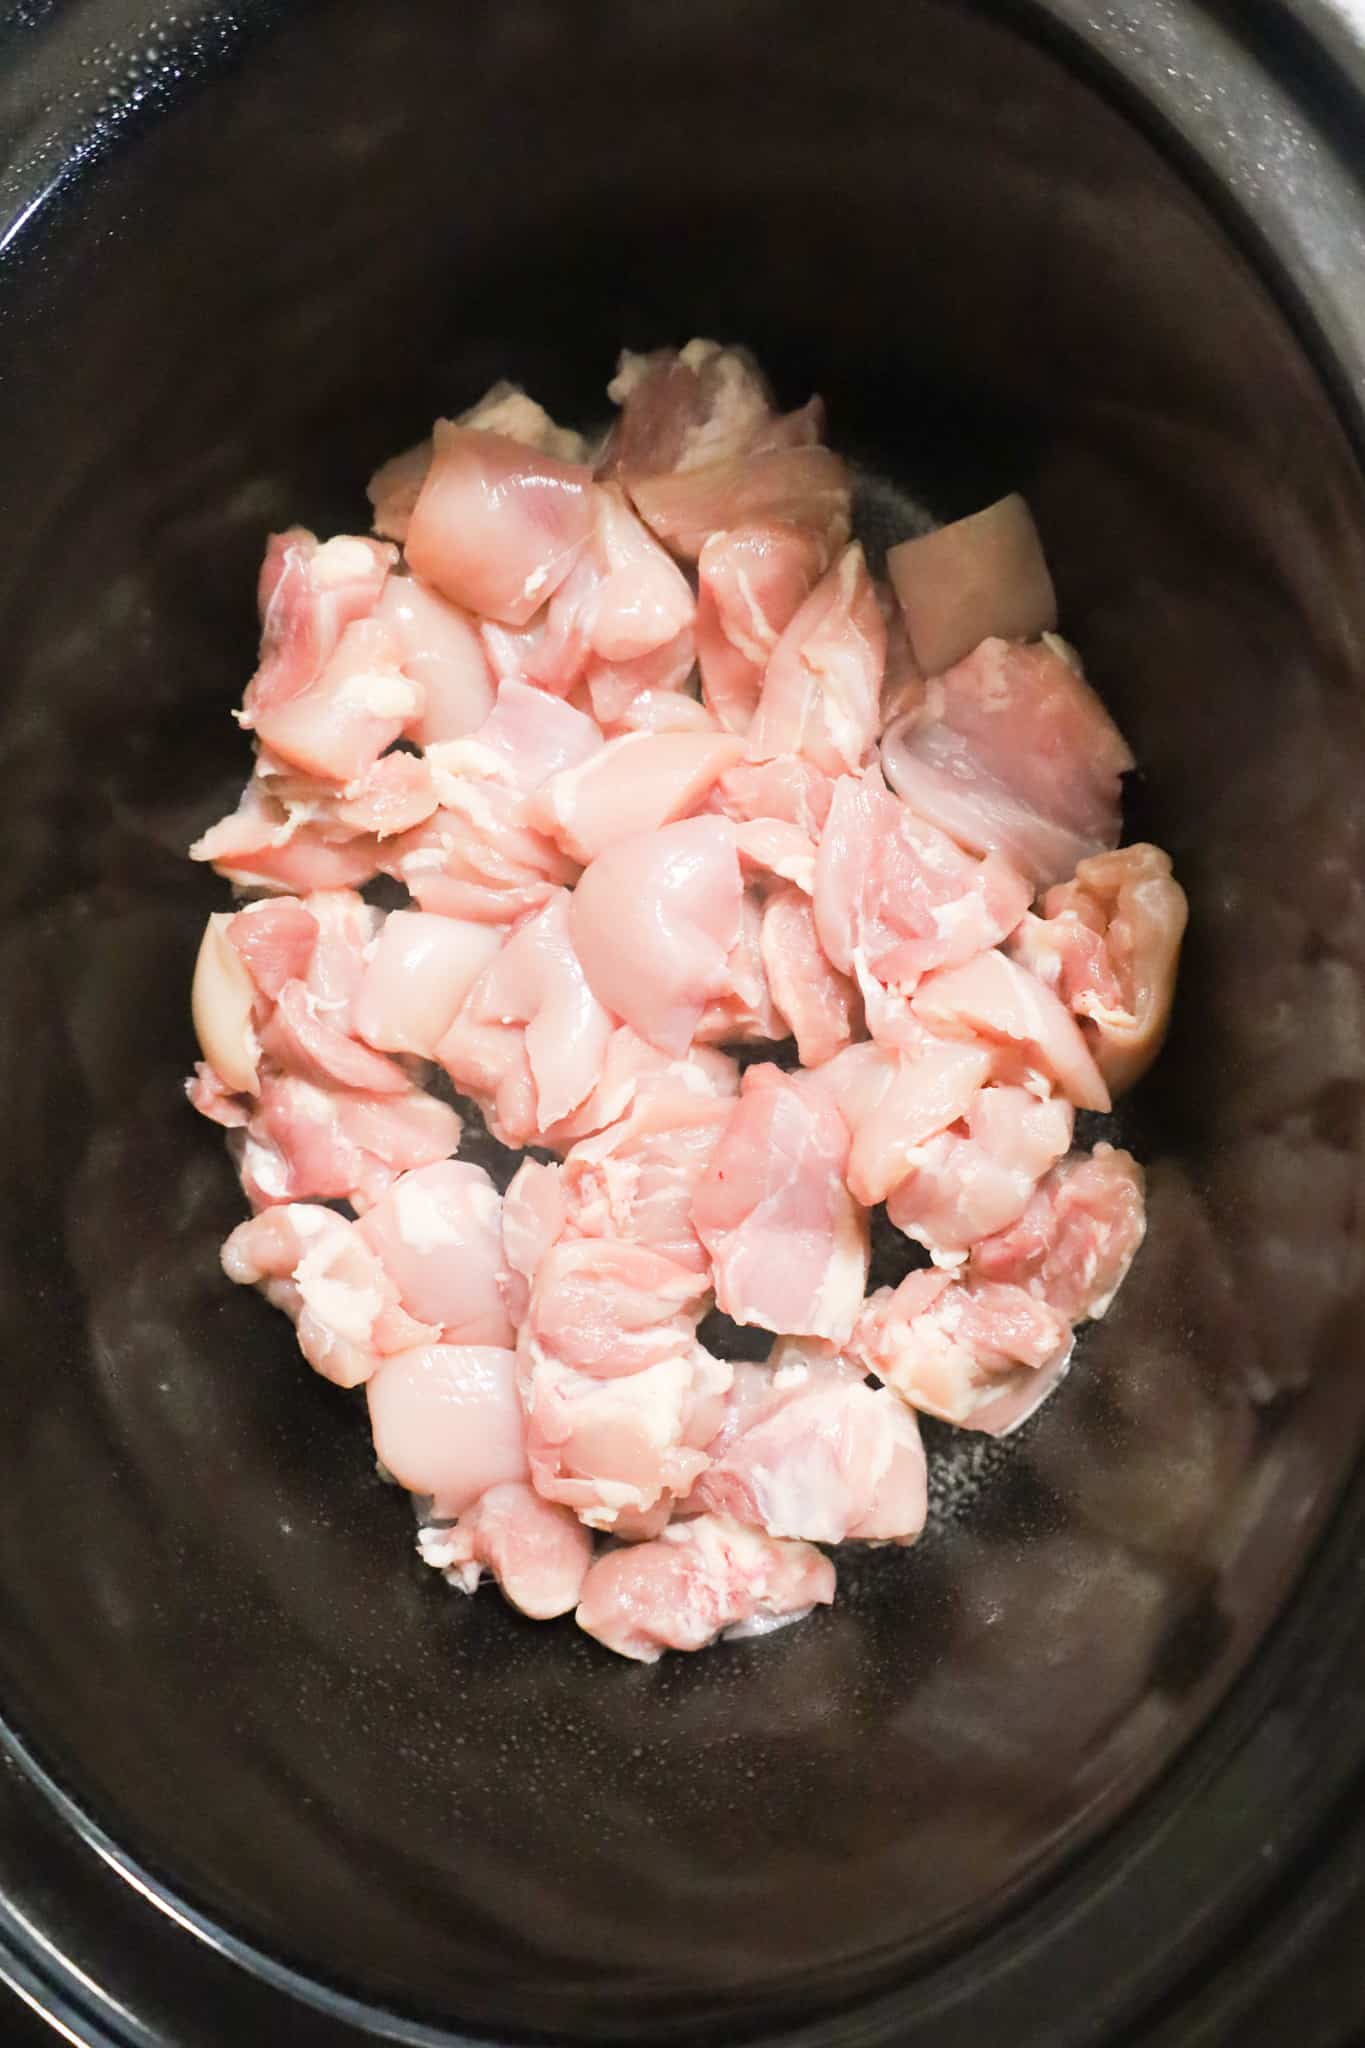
<box><xmin>882</xmin><ymin>635</ymin><xmax>1134</xmax><ymax>891</ymax></box>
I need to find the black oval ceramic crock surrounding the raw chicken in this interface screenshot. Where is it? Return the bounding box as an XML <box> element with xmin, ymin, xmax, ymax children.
<box><xmin>0</xmin><ymin>0</ymin><xmax>1365</xmax><ymax>2048</ymax></box>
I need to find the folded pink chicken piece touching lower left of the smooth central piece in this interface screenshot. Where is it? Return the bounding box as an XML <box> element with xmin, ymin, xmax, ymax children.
<box><xmin>436</xmin><ymin>889</ymin><xmax>614</xmax><ymax>1145</ymax></box>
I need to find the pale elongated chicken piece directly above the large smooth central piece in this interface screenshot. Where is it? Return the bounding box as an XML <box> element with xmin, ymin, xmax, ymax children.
<box><xmin>532</xmin><ymin>733</ymin><xmax>743</xmax><ymax>864</ymax></box>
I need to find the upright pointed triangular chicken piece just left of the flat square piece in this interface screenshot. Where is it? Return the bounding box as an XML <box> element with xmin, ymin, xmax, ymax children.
<box><xmin>749</xmin><ymin>543</ymin><xmax>886</xmax><ymax>776</ymax></box>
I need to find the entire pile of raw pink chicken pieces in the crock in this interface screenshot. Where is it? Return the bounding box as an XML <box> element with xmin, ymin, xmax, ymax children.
<box><xmin>190</xmin><ymin>342</ymin><xmax>1185</xmax><ymax>1659</ymax></box>
